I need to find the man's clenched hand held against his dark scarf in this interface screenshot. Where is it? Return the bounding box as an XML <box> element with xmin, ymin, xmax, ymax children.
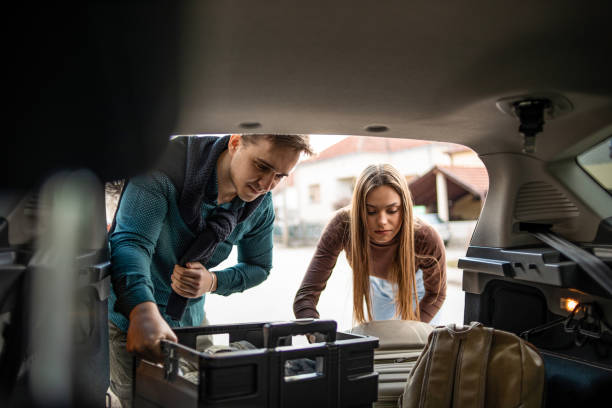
<box><xmin>170</xmin><ymin>262</ymin><xmax>217</xmax><ymax>298</ymax></box>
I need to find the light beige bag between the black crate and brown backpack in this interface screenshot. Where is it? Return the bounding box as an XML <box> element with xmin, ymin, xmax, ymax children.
<box><xmin>351</xmin><ymin>320</ymin><xmax>433</xmax><ymax>408</ymax></box>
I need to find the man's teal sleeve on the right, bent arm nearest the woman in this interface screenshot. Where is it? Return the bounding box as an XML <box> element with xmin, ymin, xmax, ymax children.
<box><xmin>215</xmin><ymin>194</ymin><xmax>274</xmax><ymax>296</ymax></box>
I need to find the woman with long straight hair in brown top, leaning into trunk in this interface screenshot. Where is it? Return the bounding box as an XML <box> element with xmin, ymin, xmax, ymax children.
<box><xmin>293</xmin><ymin>164</ymin><xmax>446</xmax><ymax>324</ymax></box>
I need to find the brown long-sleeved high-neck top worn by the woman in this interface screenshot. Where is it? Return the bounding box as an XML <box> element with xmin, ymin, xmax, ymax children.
<box><xmin>293</xmin><ymin>209</ymin><xmax>446</xmax><ymax>322</ymax></box>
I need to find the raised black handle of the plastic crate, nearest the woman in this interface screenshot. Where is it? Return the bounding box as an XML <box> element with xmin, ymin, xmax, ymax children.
<box><xmin>263</xmin><ymin>319</ymin><xmax>338</xmax><ymax>348</ymax></box>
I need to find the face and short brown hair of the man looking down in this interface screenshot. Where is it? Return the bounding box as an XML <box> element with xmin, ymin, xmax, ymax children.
<box><xmin>228</xmin><ymin>136</ymin><xmax>300</xmax><ymax>202</ymax></box>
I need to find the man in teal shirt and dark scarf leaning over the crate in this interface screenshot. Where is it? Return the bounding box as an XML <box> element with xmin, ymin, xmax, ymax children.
<box><xmin>109</xmin><ymin>135</ymin><xmax>312</xmax><ymax>406</ymax></box>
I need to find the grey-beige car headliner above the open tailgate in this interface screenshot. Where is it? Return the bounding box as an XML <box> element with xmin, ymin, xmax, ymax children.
<box><xmin>176</xmin><ymin>0</ymin><xmax>612</xmax><ymax>160</ymax></box>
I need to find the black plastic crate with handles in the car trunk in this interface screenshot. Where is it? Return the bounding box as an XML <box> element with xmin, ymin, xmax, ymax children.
<box><xmin>134</xmin><ymin>320</ymin><xmax>378</xmax><ymax>408</ymax></box>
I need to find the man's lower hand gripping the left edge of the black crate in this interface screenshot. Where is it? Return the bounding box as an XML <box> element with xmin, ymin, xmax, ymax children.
<box><xmin>126</xmin><ymin>302</ymin><xmax>178</xmax><ymax>362</ymax></box>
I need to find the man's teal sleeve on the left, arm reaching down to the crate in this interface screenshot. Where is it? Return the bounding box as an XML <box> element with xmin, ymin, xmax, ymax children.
<box><xmin>109</xmin><ymin>174</ymin><xmax>168</xmax><ymax>318</ymax></box>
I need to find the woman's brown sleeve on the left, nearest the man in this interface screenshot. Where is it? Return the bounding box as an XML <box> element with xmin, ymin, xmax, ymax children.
<box><xmin>293</xmin><ymin>210</ymin><xmax>348</xmax><ymax>319</ymax></box>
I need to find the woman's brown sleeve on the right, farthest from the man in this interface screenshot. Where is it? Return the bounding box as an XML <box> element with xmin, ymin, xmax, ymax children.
<box><xmin>414</xmin><ymin>224</ymin><xmax>446</xmax><ymax>323</ymax></box>
